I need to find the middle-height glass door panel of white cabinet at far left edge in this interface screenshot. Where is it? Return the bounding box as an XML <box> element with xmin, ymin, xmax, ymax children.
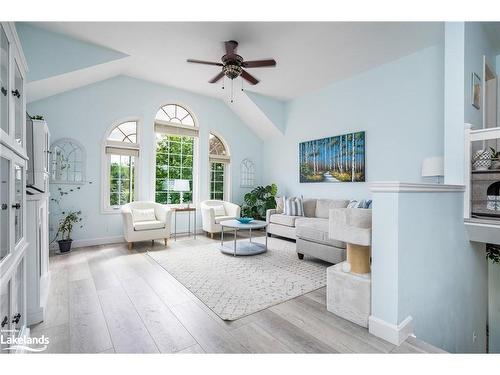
<box><xmin>0</xmin><ymin>158</ymin><xmax>10</xmax><ymax>261</ymax></box>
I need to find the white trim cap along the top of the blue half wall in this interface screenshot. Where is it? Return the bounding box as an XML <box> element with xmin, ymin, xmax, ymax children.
<box><xmin>370</xmin><ymin>181</ymin><xmax>465</xmax><ymax>193</ymax></box>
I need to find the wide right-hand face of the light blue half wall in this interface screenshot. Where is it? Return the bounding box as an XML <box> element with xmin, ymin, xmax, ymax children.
<box><xmin>394</xmin><ymin>193</ymin><xmax>488</xmax><ymax>353</ymax></box>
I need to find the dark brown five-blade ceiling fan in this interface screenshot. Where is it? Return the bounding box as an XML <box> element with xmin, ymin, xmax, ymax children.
<box><xmin>187</xmin><ymin>40</ymin><xmax>276</xmax><ymax>85</ymax></box>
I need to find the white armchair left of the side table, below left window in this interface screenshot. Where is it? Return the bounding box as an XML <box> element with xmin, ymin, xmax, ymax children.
<box><xmin>121</xmin><ymin>201</ymin><xmax>172</xmax><ymax>249</ymax></box>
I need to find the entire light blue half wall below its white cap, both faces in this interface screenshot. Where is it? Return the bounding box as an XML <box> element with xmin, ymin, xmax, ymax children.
<box><xmin>372</xmin><ymin>192</ymin><xmax>488</xmax><ymax>353</ymax></box>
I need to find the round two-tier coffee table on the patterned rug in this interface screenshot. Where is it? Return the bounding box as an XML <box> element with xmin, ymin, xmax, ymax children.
<box><xmin>219</xmin><ymin>220</ymin><xmax>267</xmax><ymax>256</ymax></box>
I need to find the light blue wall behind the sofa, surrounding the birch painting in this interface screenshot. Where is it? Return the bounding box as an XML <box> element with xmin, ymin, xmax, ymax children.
<box><xmin>264</xmin><ymin>46</ymin><xmax>443</xmax><ymax>198</ymax></box>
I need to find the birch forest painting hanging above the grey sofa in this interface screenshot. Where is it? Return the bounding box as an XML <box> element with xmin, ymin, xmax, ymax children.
<box><xmin>299</xmin><ymin>132</ymin><xmax>365</xmax><ymax>182</ymax></box>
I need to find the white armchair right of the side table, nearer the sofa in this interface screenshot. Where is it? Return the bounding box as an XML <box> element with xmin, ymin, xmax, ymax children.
<box><xmin>200</xmin><ymin>199</ymin><xmax>241</xmax><ymax>238</ymax></box>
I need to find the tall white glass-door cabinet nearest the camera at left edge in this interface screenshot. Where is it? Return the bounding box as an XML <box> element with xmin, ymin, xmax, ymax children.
<box><xmin>0</xmin><ymin>22</ymin><xmax>28</xmax><ymax>353</ymax></box>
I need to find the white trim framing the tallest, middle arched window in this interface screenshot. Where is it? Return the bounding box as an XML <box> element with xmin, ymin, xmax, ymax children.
<box><xmin>150</xmin><ymin>100</ymin><xmax>201</xmax><ymax>208</ymax></box>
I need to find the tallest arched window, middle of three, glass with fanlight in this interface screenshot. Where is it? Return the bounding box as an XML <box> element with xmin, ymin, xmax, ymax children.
<box><xmin>155</xmin><ymin>104</ymin><xmax>198</xmax><ymax>204</ymax></box>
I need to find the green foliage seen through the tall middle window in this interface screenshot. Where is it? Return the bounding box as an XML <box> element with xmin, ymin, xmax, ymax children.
<box><xmin>155</xmin><ymin>135</ymin><xmax>194</xmax><ymax>204</ymax></box>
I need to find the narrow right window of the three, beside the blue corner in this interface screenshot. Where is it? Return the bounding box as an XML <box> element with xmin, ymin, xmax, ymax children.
<box><xmin>208</xmin><ymin>134</ymin><xmax>229</xmax><ymax>200</ymax></box>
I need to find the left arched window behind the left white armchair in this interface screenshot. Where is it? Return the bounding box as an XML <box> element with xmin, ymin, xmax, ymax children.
<box><xmin>102</xmin><ymin>121</ymin><xmax>139</xmax><ymax>212</ymax></box>
